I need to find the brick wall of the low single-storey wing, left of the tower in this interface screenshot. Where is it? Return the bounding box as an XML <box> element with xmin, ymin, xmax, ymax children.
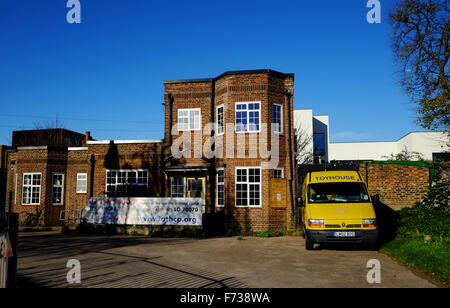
<box><xmin>6</xmin><ymin>143</ymin><xmax>161</xmax><ymax>225</ymax></box>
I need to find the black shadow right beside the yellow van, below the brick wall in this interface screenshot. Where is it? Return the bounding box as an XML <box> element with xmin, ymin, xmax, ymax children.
<box><xmin>374</xmin><ymin>201</ymin><xmax>400</xmax><ymax>245</ymax></box>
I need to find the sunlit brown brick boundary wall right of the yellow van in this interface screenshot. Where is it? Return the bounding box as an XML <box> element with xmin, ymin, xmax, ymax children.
<box><xmin>359</xmin><ymin>162</ymin><xmax>430</xmax><ymax>210</ymax></box>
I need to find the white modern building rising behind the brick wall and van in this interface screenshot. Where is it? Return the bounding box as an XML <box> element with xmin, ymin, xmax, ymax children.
<box><xmin>294</xmin><ymin>109</ymin><xmax>449</xmax><ymax>163</ymax></box>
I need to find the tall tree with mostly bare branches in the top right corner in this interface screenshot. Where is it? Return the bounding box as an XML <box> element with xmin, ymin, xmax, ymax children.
<box><xmin>390</xmin><ymin>0</ymin><xmax>450</xmax><ymax>131</ymax></box>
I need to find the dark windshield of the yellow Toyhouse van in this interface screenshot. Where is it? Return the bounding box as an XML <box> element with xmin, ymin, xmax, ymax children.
<box><xmin>308</xmin><ymin>183</ymin><xmax>369</xmax><ymax>203</ymax></box>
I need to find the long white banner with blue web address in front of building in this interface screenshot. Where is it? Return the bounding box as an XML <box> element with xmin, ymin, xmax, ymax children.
<box><xmin>85</xmin><ymin>198</ymin><xmax>202</xmax><ymax>226</ymax></box>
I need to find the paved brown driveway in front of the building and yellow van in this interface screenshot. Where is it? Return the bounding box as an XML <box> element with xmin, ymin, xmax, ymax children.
<box><xmin>18</xmin><ymin>233</ymin><xmax>434</xmax><ymax>288</ymax></box>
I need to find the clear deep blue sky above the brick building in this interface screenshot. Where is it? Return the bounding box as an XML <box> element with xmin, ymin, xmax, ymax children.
<box><xmin>0</xmin><ymin>0</ymin><xmax>422</xmax><ymax>144</ymax></box>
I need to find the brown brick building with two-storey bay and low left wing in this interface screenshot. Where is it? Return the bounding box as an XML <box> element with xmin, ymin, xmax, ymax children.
<box><xmin>6</xmin><ymin>70</ymin><xmax>295</xmax><ymax>231</ymax></box>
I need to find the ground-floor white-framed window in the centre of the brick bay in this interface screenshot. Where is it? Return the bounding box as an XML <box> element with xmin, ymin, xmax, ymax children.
<box><xmin>236</xmin><ymin>168</ymin><xmax>261</xmax><ymax>207</ymax></box>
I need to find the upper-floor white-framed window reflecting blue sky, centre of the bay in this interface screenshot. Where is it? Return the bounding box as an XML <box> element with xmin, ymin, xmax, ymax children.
<box><xmin>236</xmin><ymin>102</ymin><xmax>261</xmax><ymax>133</ymax></box>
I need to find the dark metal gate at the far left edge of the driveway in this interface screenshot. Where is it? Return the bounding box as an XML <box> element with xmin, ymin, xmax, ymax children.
<box><xmin>0</xmin><ymin>212</ymin><xmax>18</xmax><ymax>288</ymax></box>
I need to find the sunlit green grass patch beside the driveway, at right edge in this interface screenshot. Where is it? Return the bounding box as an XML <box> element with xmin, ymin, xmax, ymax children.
<box><xmin>381</xmin><ymin>207</ymin><xmax>450</xmax><ymax>282</ymax></box>
